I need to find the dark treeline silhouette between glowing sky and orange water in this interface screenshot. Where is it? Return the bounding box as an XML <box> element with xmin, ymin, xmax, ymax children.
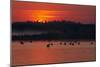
<box><xmin>12</xmin><ymin>21</ymin><xmax>95</xmax><ymax>40</ymax></box>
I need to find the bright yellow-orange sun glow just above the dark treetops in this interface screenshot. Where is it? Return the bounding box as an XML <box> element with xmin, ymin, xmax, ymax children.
<box><xmin>32</xmin><ymin>10</ymin><xmax>54</xmax><ymax>22</ymax></box>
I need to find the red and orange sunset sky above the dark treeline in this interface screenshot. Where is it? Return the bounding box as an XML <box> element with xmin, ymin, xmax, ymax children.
<box><xmin>12</xmin><ymin>1</ymin><xmax>96</xmax><ymax>23</ymax></box>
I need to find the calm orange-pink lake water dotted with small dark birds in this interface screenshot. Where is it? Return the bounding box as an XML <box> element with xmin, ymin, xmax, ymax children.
<box><xmin>11</xmin><ymin>41</ymin><xmax>96</xmax><ymax>65</ymax></box>
